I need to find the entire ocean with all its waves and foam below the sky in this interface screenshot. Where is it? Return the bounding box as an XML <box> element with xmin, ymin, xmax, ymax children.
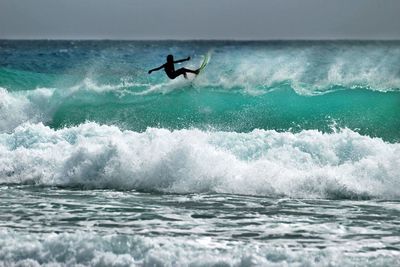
<box><xmin>0</xmin><ymin>41</ymin><xmax>400</xmax><ymax>266</ymax></box>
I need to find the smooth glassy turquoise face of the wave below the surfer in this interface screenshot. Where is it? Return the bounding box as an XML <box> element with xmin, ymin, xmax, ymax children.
<box><xmin>49</xmin><ymin>86</ymin><xmax>400</xmax><ymax>140</ymax></box>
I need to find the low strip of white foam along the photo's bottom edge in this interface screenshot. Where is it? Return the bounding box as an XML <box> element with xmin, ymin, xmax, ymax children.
<box><xmin>0</xmin><ymin>230</ymin><xmax>399</xmax><ymax>267</ymax></box>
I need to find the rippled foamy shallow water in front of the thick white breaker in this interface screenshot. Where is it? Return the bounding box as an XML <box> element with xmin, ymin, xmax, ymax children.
<box><xmin>0</xmin><ymin>185</ymin><xmax>400</xmax><ymax>266</ymax></box>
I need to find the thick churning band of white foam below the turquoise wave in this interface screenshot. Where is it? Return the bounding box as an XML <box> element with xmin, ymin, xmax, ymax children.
<box><xmin>0</xmin><ymin>123</ymin><xmax>400</xmax><ymax>199</ymax></box>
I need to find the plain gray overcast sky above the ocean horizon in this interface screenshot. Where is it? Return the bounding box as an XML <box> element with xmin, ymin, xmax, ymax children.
<box><xmin>0</xmin><ymin>0</ymin><xmax>400</xmax><ymax>39</ymax></box>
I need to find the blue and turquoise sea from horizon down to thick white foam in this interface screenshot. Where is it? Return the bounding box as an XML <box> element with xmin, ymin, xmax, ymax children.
<box><xmin>0</xmin><ymin>41</ymin><xmax>400</xmax><ymax>142</ymax></box>
